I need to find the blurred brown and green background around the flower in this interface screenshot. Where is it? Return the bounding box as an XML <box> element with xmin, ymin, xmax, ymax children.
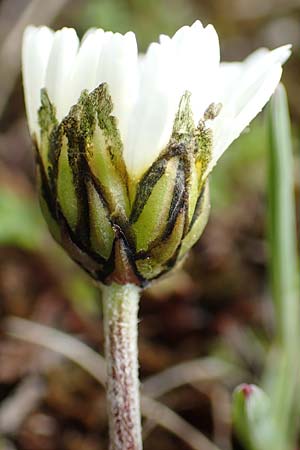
<box><xmin>0</xmin><ymin>0</ymin><xmax>300</xmax><ymax>450</ymax></box>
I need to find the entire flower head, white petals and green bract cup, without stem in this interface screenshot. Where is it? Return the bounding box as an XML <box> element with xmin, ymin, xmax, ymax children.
<box><xmin>23</xmin><ymin>21</ymin><xmax>290</xmax><ymax>284</ymax></box>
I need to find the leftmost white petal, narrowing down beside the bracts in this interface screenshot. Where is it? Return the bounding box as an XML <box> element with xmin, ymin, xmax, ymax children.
<box><xmin>22</xmin><ymin>26</ymin><xmax>54</xmax><ymax>138</ymax></box>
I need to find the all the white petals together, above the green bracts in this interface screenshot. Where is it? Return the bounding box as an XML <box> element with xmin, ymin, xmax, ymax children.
<box><xmin>23</xmin><ymin>20</ymin><xmax>291</xmax><ymax>179</ymax></box>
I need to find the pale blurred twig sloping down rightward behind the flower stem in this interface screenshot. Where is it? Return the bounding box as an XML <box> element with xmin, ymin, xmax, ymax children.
<box><xmin>4</xmin><ymin>317</ymin><xmax>220</xmax><ymax>450</ymax></box>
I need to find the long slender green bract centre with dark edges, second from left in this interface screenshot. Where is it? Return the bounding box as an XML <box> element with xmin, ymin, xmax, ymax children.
<box><xmin>57</xmin><ymin>136</ymin><xmax>78</xmax><ymax>231</ymax></box>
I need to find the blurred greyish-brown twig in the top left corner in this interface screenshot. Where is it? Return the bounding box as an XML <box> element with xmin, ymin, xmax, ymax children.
<box><xmin>0</xmin><ymin>0</ymin><xmax>69</xmax><ymax>117</ymax></box>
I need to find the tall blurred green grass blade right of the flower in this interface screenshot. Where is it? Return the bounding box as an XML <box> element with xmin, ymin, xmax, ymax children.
<box><xmin>264</xmin><ymin>85</ymin><xmax>300</xmax><ymax>450</ymax></box>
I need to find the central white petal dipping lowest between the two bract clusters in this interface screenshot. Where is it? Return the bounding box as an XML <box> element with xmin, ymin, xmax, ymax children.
<box><xmin>124</xmin><ymin>40</ymin><xmax>183</xmax><ymax>177</ymax></box>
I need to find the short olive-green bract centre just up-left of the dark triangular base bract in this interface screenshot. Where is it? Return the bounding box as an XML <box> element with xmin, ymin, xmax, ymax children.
<box><xmin>87</xmin><ymin>178</ymin><xmax>115</xmax><ymax>259</ymax></box>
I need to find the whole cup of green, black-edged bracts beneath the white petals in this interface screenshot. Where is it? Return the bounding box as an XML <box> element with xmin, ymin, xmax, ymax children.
<box><xmin>35</xmin><ymin>83</ymin><xmax>214</xmax><ymax>286</ymax></box>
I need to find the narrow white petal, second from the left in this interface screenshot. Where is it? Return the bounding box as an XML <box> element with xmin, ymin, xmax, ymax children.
<box><xmin>46</xmin><ymin>28</ymin><xmax>79</xmax><ymax>120</ymax></box>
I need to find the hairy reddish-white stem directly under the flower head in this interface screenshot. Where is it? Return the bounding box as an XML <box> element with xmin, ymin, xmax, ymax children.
<box><xmin>103</xmin><ymin>284</ymin><xmax>142</xmax><ymax>450</ymax></box>
